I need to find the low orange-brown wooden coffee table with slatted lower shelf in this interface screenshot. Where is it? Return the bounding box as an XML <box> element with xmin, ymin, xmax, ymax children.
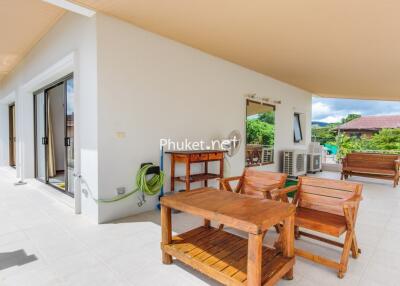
<box><xmin>161</xmin><ymin>188</ymin><xmax>295</xmax><ymax>286</ymax></box>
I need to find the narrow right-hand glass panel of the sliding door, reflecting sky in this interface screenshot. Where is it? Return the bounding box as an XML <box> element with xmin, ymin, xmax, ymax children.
<box><xmin>65</xmin><ymin>78</ymin><xmax>74</xmax><ymax>194</ymax></box>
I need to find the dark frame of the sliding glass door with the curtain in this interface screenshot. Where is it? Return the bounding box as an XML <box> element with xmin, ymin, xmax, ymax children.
<box><xmin>33</xmin><ymin>73</ymin><xmax>74</xmax><ymax>197</ymax></box>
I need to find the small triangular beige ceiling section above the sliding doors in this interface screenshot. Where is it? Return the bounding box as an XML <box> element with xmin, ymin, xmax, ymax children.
<box><xmin>0</xmin><ymin>0</ymin><xmax>64</xmax><ymax>80</ymax></box>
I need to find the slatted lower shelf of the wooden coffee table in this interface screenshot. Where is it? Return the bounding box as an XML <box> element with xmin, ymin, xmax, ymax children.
<box><xmin>163</xmin><ymin>227</ymin><xmax>294</xmax><ymax>285</ymax></box>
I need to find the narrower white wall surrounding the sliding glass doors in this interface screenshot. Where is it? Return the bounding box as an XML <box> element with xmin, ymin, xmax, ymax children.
<box><xmin>0</xmin><ymin>13</ymin><xmax>98</xmax><ymax>222</ymax></box>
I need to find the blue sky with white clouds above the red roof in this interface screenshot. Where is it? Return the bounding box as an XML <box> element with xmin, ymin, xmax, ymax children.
<box><xmin>312</xmin><ymin>97</ymin><xmax>400</xmax><ymax>123</ymax></box>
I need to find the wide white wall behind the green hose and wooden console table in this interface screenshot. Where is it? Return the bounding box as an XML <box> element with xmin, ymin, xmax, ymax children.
<box><xmin>97</xmin><ymin>14</ymin><xmax>312</xmax><ymax>221</ymax></box>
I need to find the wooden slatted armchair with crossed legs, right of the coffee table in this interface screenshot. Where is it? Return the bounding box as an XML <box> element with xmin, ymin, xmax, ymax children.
<box><xmin>281</xmin><ymin>177</ymin><xmax>362</xmax><ymax>278</ymax></box>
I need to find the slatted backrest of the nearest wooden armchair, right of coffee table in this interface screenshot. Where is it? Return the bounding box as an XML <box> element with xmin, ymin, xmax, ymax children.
<box><xmin>297</xmin><ymin>177</ymin><xmax>362</xmax><ymax>216</ymax></box>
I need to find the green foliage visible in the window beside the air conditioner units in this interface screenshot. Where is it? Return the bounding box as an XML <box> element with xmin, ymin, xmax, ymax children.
<box><xmin>246</xmin><ymin>119</ymin><xmax>275</xmax><ymax>146</ymax></box>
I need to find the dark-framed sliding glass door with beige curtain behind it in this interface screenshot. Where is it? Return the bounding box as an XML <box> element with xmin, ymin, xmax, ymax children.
<box><xmin>34</xmin><ymin>76</ymin><xmax>74</xmax><ymax>195</ymax></box>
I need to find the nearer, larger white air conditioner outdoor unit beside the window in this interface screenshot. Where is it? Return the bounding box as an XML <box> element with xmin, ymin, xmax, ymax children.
<box><xmin>283</xmin><ymin>149</ymin><xmax>307</xmax><ymax>177</ymax></box>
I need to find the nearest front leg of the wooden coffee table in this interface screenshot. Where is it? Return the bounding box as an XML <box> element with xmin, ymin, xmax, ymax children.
<box><xmin>247</xmin><ymin>233</ymin><xmax>263</xmax><ymax>286</ymax></box>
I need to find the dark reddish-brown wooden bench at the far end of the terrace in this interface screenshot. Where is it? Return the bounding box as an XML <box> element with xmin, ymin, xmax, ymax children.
<box><xmin>341</xmin><ymin>153</ymin><xmax>400</xmax><ymax>187</ymax></box>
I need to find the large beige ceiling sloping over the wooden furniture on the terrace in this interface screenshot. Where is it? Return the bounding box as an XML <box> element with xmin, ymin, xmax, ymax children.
<box><xmin>71</xmin><ymin>0</ymin><xmax>400</xmax><ymax>100</ymax></box>
